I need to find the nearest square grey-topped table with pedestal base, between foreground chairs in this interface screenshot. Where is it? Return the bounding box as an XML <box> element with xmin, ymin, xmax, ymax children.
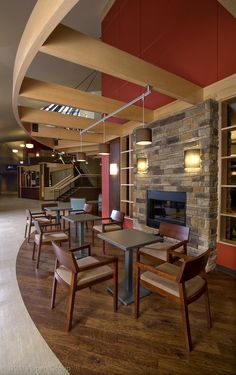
<box><xmin>98</xmin><ymin>229</ymin><xmax>162</xmax><ymax>305</ymax></box>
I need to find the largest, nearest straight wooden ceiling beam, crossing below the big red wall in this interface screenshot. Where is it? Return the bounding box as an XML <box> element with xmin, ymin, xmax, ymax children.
<box><xmin>40</xmin><ymin>24</ymin><xmax>202</xmax><ymax>104</ymax></box>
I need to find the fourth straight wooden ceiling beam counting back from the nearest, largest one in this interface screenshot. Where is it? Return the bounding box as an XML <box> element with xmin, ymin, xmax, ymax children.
<box><xmin>30</xmin><ymin>125</ymin><xmax>103</xmax><ymax>143</ymax></box>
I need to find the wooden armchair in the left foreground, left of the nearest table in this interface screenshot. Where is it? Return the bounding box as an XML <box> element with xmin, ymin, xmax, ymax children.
<box><xmin>51</xmin><ymin>242</ymin><xmax>118</xmax><ymax>331</ymax></box>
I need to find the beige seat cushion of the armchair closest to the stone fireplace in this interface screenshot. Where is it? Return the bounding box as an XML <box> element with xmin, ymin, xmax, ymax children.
<box><xmin>139</xmin><ymin>241</ymin><xmax>184</xmax><ymax>262</ymax></box>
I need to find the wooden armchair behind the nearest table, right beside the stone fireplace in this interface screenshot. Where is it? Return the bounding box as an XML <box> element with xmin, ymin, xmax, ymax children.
<box><xmin>137</xmin><ymin>222</ymin><xmax>189</xmax><ymax>262</ymax></box>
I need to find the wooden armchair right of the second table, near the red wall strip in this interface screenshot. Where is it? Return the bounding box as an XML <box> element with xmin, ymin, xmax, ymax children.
<box><xmin>92</xmin><ymin>210</ymin><xmax>125</xmax><ymax>254</ymax></box>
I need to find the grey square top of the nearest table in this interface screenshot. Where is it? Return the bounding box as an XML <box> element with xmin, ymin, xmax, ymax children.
<box><xmin>98</xmin><ymin>229</ymin><xmax>160</xmax><ymax>251</ymax></box>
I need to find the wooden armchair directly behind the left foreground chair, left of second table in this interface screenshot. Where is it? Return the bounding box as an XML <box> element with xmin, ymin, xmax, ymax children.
<box><xmin>32</xmin><ymin>220</ymin><xmax>71</xmax><ymax>269</ymax></box>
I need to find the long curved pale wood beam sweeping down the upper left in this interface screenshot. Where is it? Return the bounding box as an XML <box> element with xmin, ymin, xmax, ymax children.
<box><xmin>12</xmin><ymin>0</ymin><xmax>79</xmax><ymax>143</ymax></box>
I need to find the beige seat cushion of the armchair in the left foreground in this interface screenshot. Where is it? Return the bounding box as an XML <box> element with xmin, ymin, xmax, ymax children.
<box><xmin>56</xmin><ymin>256</ymin><xmax>113</xmax><ymax>286</ymax></box>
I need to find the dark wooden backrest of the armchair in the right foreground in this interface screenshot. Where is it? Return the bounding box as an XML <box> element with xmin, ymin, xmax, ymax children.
<box><xmin>176</xmin><ymin>249</ymin><xmax>210</xmax><ymax>283</ymax></box>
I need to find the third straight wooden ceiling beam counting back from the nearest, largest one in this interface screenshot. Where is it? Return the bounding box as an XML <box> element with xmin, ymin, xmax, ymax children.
<box><xmin>18</xmin><ymin>106</ymin><xmax>125</xmax><ymax>137</ymax></box>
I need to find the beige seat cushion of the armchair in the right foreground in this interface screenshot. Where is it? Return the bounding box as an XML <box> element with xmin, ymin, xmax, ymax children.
<box><xmin>141</xmin><ymin>263</ymin><xmax>205</xmax><ymax>298</ymax></box>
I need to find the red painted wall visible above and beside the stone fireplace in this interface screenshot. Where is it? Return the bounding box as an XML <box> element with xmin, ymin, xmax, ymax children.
<box><xmin>102</xmin><ymin>0</ymin><xmax>236</xmax><ymax>269</ymax></box>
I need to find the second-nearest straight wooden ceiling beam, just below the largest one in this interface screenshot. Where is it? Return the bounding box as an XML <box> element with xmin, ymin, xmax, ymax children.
<box><xmin>20</xmin><ymin>77</ymin><xmax>153</xmax><ymax>122</ymax></box>
